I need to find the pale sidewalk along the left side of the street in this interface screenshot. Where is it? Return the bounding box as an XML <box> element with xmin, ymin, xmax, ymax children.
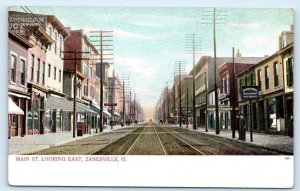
<box><xmin>8</xmin><ymin>125</ymin><xmax>128</xmax><ymax>155</ymax></box>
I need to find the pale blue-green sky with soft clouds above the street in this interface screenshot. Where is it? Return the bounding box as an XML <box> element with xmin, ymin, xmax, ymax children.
<box><xmin>11</xmin><ymin>7</ymin><xmax>293</xmax><ymax>115</ymax></box>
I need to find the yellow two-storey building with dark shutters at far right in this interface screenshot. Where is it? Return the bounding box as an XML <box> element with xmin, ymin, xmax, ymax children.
<box><xmin>237</xmin><ymin>33</ymin><xmax>294</xmax><ymax>136</ymax></box>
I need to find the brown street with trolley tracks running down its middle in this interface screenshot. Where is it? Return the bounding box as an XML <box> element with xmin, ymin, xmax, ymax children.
<box><xmin>18</xmin><ymin>123</ymin><xmax>284</xmax><ymax>155</ymax></box>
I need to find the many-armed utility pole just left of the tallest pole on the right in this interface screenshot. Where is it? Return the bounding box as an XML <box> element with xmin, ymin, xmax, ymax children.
<box><xmin>186</xmin><ymin>33</ymin><xmax>201</xmax><ymax>130</ymax></box>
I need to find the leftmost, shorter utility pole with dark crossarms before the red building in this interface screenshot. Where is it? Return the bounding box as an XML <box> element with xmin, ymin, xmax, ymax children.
<box><xmin>62</xmin><ymin>49</ymin><xmax>90</xmax><ymax>138</ymax></box>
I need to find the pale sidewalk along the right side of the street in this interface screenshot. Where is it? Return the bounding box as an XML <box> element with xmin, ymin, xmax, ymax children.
<box><xmin>172</xmin><ymin>125</ymin><xmax>294</xmax><ymax>154</ymax></box>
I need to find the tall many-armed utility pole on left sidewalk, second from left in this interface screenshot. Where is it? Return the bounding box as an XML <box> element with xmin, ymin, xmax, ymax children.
<box><xmin>90</xmin><ymin>30</ymin><xmax>113</xmax><ymax>132</ymax></box>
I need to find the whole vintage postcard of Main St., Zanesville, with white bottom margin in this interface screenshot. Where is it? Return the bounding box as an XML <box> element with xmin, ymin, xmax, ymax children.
<box><xmin>7</xmin><ymin>6</ymin><xmax>294</xmax><ymax>188</ymax></box>
